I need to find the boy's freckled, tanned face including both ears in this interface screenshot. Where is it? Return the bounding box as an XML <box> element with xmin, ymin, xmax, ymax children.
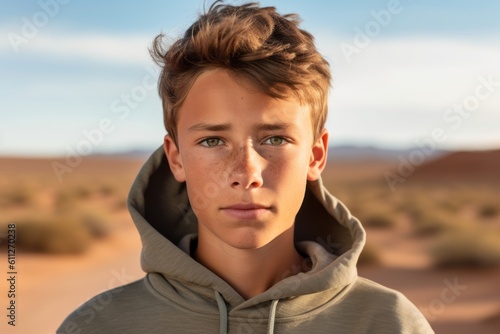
<box><xmin>165</xmin><ymin>69</ymin><xmax>328</xmax><ymax>249</ymax></box>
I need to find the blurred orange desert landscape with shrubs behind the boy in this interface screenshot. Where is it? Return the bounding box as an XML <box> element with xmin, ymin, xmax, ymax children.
<box><xmin>0</xmin><ymin>148</ymin><xmax>500</xmax><ymax>334</ymax></box>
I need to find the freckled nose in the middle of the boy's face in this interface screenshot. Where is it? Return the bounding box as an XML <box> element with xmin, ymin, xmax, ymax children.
<box><xmin>229</xmin><ymin>145</ymin><xmax>264</xmax><ymax>189</ymax></box>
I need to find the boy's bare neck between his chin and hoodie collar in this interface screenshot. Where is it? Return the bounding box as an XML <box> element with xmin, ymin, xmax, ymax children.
<box><xmin>194</xmin><ymin>228</ymin><xmax>309</xmax><ymax>299</ymax></box>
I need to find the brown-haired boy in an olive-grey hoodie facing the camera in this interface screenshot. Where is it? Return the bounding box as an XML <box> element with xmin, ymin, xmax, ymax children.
<box><xmin>58</xmin><ymin>2</ymin><xmax>432</xmax><ymax>333</ymax></box>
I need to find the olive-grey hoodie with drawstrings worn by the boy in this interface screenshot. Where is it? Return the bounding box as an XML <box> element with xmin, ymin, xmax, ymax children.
<box><xmin>57</xmin><ymin>148</ymin><xmax>433</xmax><ymax>334</ymax></box>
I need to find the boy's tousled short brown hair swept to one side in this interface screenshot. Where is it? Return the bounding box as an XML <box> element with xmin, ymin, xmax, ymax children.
<box><xmin>150</xmin><ymin>1</ymin><xmax>331</xmax><ymax>142</ymax></box>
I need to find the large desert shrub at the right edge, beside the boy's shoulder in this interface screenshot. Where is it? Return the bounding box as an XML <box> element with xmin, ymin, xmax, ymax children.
<box><xmin>428</xmin><ymin>224</ymin><xmax>500</xmax><ymax>267</ymax></box>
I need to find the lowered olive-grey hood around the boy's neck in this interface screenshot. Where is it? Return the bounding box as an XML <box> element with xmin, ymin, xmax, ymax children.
<box><xmin>128</xmin><ymin>147</ymin><xmax>365</xmax><ymax>316</ymax></box>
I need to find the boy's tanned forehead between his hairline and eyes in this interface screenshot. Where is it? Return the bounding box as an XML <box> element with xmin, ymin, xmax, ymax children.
<box><xmin>170</xmin><ymin>69</ymin><xmax>314</xmax><ymax>143</ymax></box>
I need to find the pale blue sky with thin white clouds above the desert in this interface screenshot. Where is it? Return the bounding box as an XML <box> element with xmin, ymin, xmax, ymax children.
<box><xmin>0</xmin><ymin>0</ymin><xmax>500</xmax><ymax>156</ymax></box>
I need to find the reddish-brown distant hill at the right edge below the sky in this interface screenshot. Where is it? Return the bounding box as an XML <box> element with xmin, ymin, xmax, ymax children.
<box><xmin>409</xmin><ymin>150</ymin><xmax>500</xmax><ymax>182</ymax></box>
